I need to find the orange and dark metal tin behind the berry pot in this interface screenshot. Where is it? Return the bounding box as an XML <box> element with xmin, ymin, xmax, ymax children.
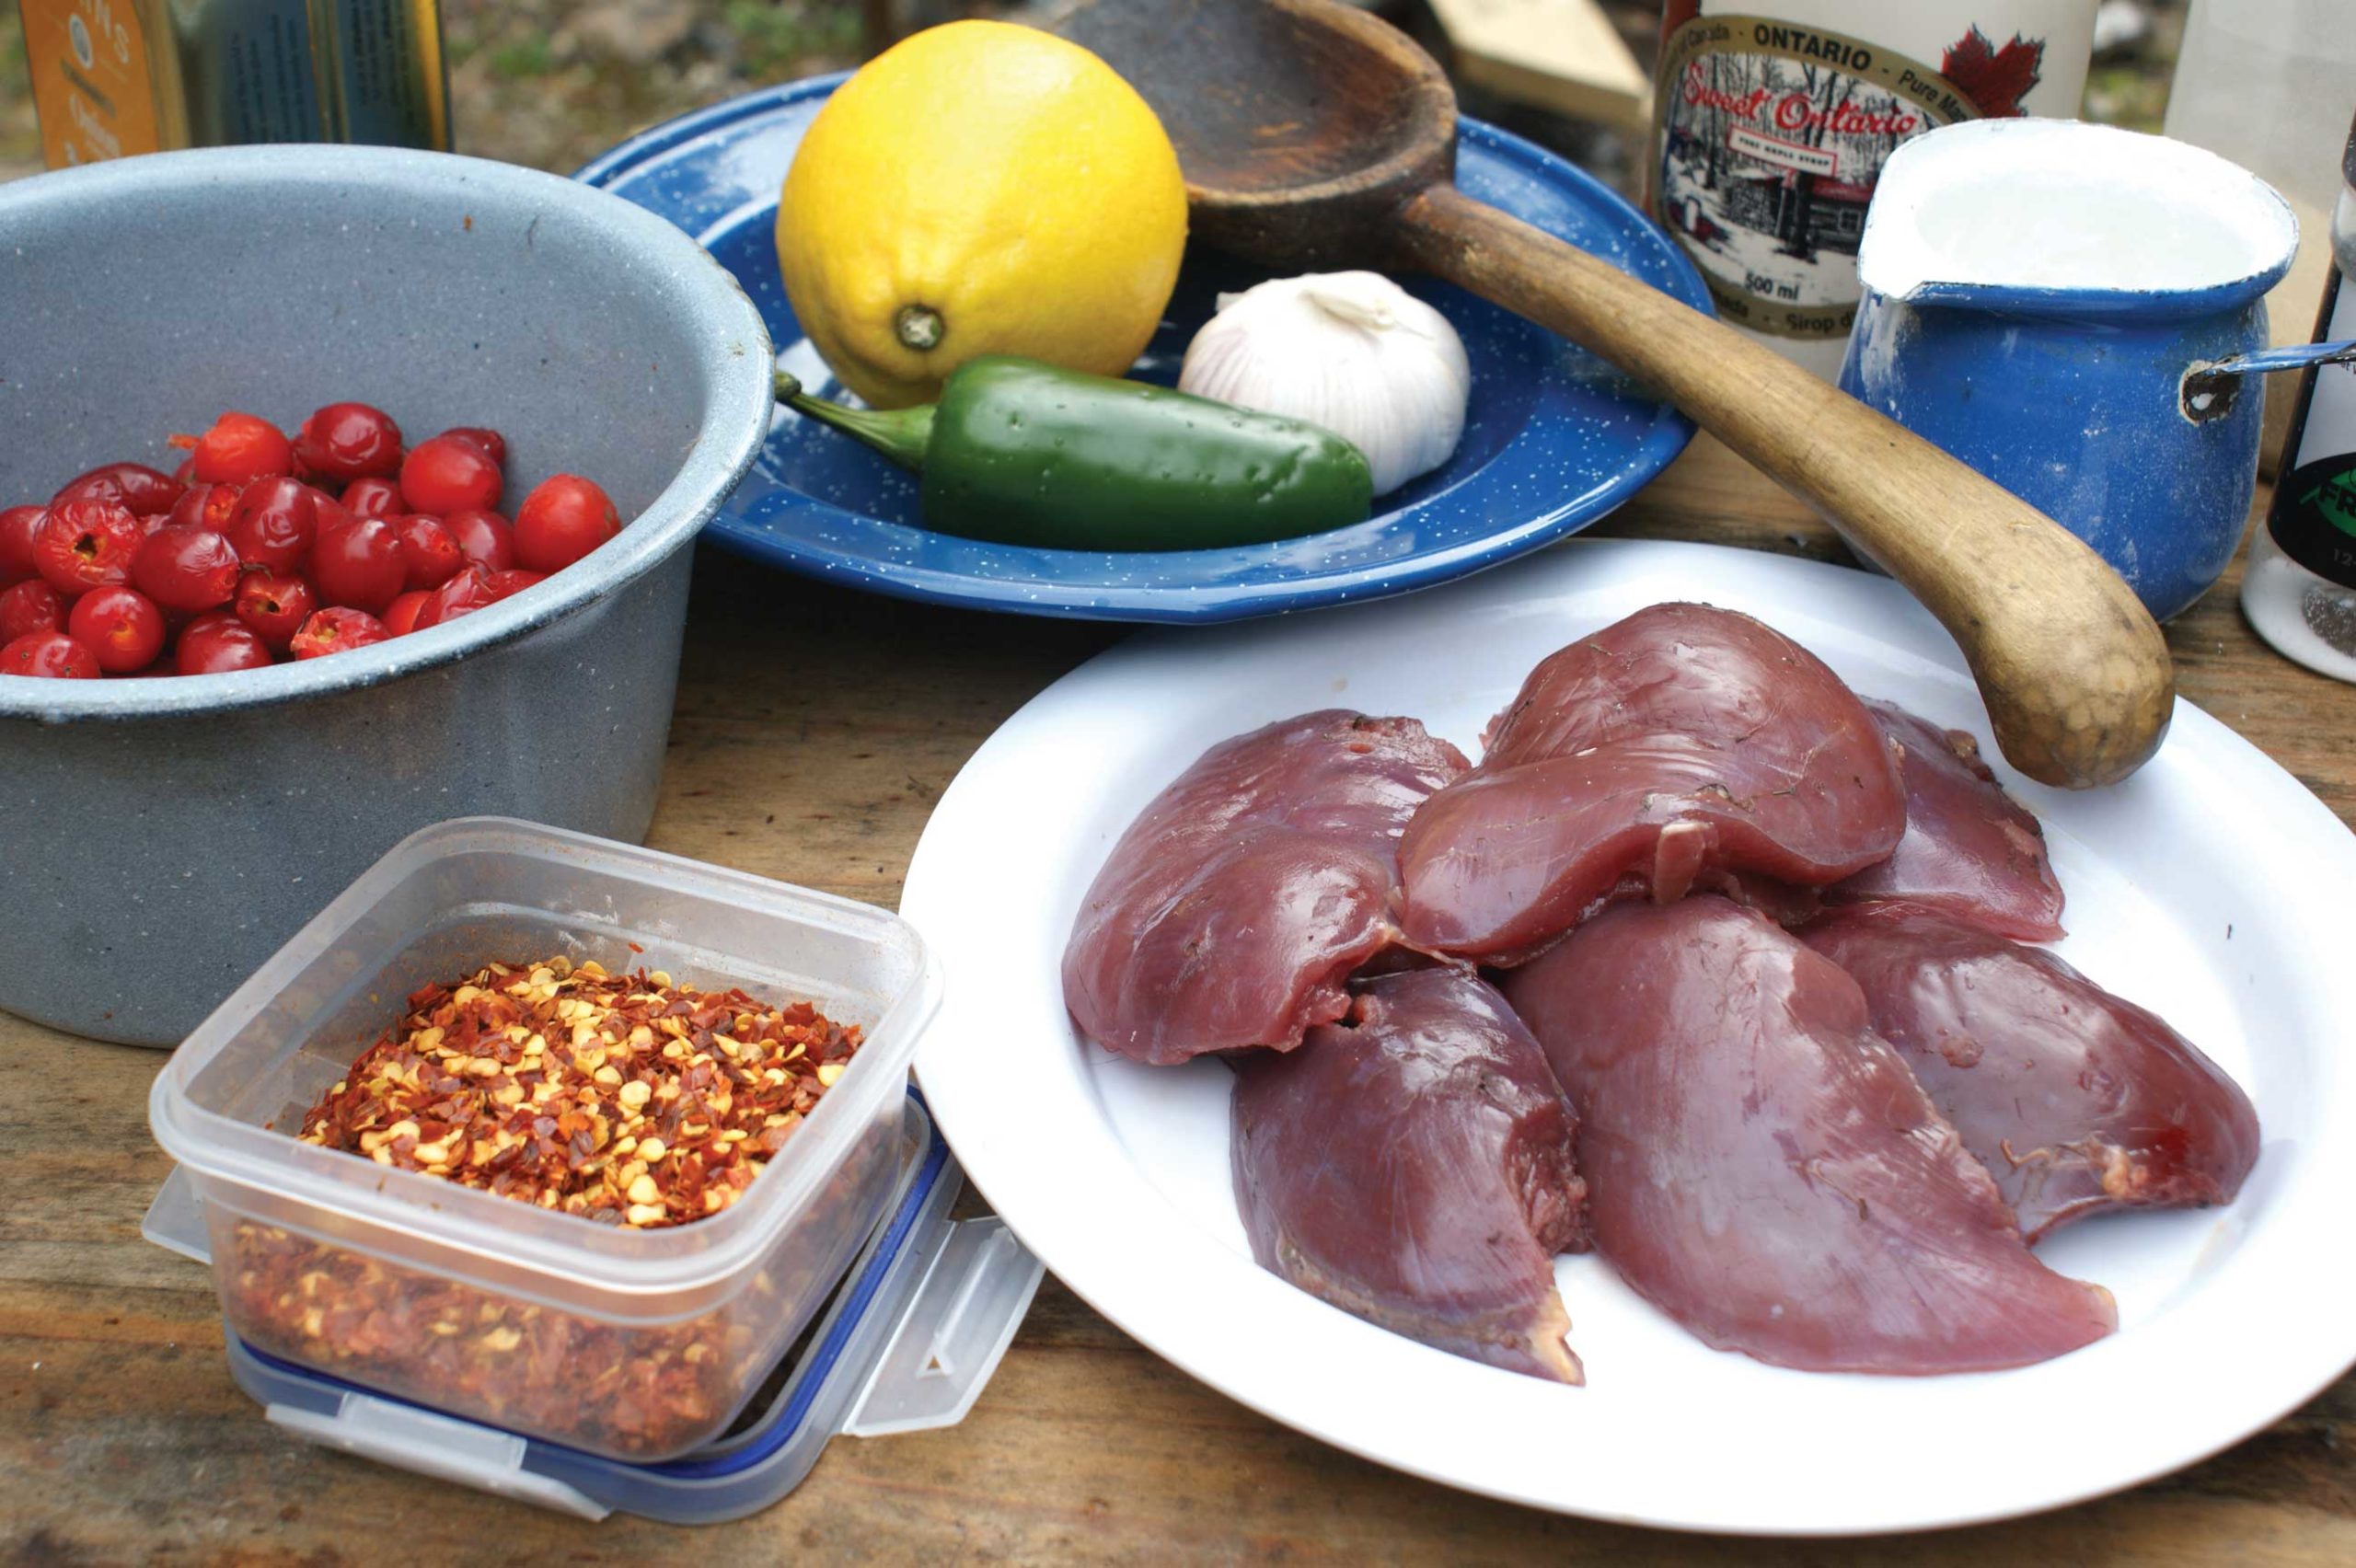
<box><xmin>18</xmin><ymin>0</ymin><xmax>450</xmax><ymax>169</ymax></box>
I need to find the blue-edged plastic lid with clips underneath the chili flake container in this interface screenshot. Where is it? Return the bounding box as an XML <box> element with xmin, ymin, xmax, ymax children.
<box><xmin>144</xmin><ymin>1095</ymin><xmax>1042</xmax><ymax>1523</ymax></box>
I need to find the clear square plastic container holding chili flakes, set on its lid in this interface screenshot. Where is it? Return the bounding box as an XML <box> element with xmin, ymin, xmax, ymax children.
<box><xmin>148</xmin><ymin>817</ymin><xmax>940</xmax><ymax>1464</ymax></box>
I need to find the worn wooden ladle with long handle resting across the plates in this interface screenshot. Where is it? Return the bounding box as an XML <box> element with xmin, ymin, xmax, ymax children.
<box><xmin>1056</xmin><ymin>0</ymin><xmax>2175</xmax><ymax>787</ymax></box>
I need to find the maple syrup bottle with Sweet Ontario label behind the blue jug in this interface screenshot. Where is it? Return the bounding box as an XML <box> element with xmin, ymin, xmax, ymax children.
<box><xmin>1645</xmin><ymin>0</ymin><xmax>2095</xmax><ymax>379</ymax></box>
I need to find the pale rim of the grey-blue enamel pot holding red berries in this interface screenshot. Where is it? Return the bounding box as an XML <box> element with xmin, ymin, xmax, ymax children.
<box><xmin>0</xmin><ymin>146</ymin><xmax>773</xmax><ymax>725</ymax></box>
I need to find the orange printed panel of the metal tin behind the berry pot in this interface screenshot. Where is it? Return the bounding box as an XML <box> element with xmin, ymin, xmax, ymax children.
<box><xmin>18</xmin><ymin>0</ymin><xmax>163</xmax><ymax>169</ymax></box>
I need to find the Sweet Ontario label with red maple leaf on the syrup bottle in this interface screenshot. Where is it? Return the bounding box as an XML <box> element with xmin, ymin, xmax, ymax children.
<box><xmin>1652</xmin><ymin>13</ymin><xmax>2045</xmax><ymax>341</ymax></box>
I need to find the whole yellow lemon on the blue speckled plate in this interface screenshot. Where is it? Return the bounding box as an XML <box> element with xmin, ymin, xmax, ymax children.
<box><xmin>778</xmin><ymin>21</ymin><xmax>1185</xmax><ymax>408</ymax></box>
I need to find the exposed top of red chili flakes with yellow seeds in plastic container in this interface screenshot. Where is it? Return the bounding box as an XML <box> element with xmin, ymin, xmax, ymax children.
<box><xmin>299</xmin><ymin>958</ymin><xmax>860</xmax><ymax>1229</ymax></box>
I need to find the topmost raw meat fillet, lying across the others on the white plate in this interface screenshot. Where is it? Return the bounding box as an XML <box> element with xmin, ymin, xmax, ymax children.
<box><xmin>1400</xmin><ymin>605</ymin><xmax>1906</xmax><ymax>963</ymax></box>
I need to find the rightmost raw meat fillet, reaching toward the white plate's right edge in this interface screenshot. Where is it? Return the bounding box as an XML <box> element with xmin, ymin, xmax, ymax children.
<box><xmin>1802</xmin><ymin>904</ymin><xmax>2257</xmax><ymax>1240</ymax></box>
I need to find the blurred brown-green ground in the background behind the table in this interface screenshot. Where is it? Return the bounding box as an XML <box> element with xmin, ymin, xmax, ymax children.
<box><xmin>0</xmin><ymin>0</ymin><xmax>2182</xmax><ymax>181</ymax></box>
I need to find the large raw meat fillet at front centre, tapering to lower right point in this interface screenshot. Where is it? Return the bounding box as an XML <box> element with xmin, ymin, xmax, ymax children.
<box><xmin>1506</xmin><ymin>897</ymin><xmax>2118</xmax><ymax>1373</ymax></box>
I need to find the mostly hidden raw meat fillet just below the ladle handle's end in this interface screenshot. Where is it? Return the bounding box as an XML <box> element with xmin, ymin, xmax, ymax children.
<box><xmin>1823</xmin><ymin>701</ymin><xmax>2062</xmax><ymax>941</ymax></box>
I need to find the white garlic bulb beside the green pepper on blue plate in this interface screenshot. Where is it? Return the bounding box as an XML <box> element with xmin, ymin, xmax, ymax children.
<box><xmin>1178</xmin><ymin>273</ymin><xmax>1472</xmax><ymax>494</ymax></box>
